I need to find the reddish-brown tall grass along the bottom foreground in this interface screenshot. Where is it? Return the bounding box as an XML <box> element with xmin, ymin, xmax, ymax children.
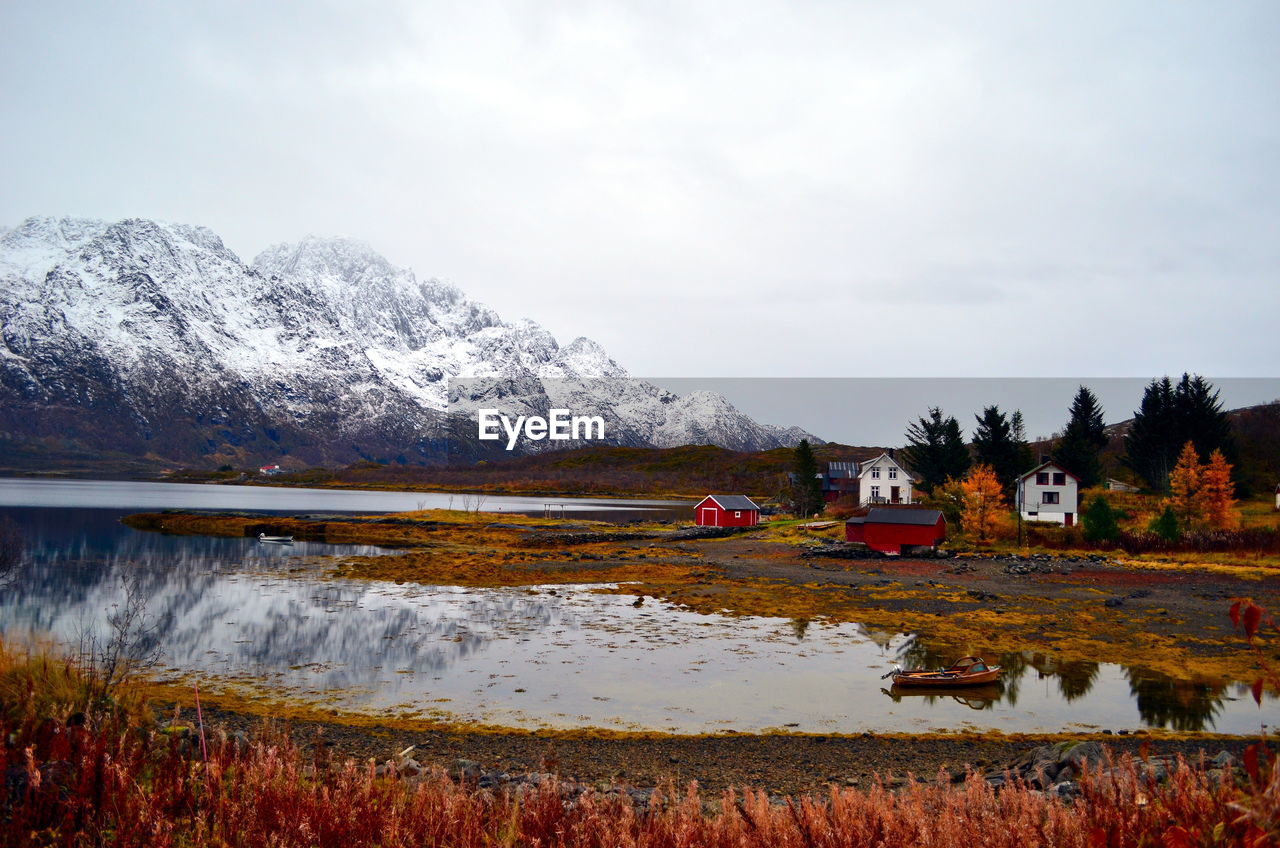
<box><xmin>0</xmin><ymin>720</ymin><xmax>1280</xmax><ymax>848</ymax></box>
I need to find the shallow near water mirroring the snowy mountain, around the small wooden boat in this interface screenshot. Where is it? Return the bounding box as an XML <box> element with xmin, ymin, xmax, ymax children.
<box><xmin>0</xmin><ymin>484</ymin><xmax>1280</xmax><ymax>734</ymax></box>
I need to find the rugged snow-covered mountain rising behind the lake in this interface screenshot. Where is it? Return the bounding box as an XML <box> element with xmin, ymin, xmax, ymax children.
<box><xmin>0</xmin><ymin>218</ymin><xmax>817</xmax><ymax>465</ymax></box>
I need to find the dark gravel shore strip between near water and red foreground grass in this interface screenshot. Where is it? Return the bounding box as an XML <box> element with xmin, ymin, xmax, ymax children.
<box><xmin>185</xmin><ymin>708</ymin><xmax>1256</xmax><ymax>795</ymax></box>
